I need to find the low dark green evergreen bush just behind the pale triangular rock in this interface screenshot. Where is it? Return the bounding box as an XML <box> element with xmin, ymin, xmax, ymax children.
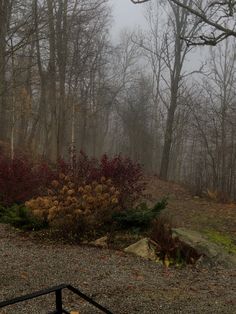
<box><xmin>113</xmin><ymin>198</ymin><xmax>167</xmax><ymax>231</ymax></box>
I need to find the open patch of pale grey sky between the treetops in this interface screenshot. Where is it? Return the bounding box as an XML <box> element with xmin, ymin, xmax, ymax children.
<box><xmin>109</xmin><ymin>0</ymin><xmax>147</xmax><ymax>40</ymax></box>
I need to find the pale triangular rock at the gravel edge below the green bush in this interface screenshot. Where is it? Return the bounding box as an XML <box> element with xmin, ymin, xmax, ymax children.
<box><xmin>124</xmin><ymin>238</ymin><xmax>157</xmax><ymax>261</ymax></box>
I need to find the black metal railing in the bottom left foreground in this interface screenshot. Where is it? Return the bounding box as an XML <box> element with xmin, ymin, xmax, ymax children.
<box><xmin>0</xmin><ymin>284</ymin><xmax>112</xmax><ymax>314</ymax></box>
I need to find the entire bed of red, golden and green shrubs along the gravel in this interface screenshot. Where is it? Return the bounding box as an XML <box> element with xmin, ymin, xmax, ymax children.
<box><xmin>0</xmin><ymin>152</ymin><xmax>158</xmax><ymax>239</ymax></box>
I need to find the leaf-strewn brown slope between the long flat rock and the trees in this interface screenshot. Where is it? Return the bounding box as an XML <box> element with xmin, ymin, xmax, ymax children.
<box><xmin>147</xmin><ymin>177</ymin><xmax>236</xmax><ymax>243</ymax></box>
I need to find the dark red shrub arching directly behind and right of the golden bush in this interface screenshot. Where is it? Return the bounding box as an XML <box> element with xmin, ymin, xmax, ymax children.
<box><xmin>67</xmin><ymin>152</ymin><xmax>144</xmax><ymax>208</ymax></box>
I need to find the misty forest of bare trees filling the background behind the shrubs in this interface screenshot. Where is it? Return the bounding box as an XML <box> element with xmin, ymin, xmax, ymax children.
<box><xmin>0</xmin><ymin>0</ymin><xmax>236</xmax><ymax>198</ymax></box>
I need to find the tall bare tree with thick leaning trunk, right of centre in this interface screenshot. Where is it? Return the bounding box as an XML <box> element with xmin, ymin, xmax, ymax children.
<box><xmin>148</xmin><ymin>1</ymin><xmax>198</xmax><ymax>179</ymax></box>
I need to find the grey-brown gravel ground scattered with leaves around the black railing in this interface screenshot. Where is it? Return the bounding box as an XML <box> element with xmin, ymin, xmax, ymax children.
<box><xmin>0</xmin><ymin>225</ymin><xmax>236</xmax><ymax>314</ymax></box>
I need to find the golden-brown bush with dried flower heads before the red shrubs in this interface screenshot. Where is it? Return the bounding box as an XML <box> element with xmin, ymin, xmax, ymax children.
<box><xmin>25</xmin><ymin>173</ymin><xmax>120</xmax><ymax>233</ymax></box>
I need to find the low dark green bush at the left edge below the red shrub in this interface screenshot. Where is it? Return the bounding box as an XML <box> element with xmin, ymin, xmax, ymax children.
<box><xmin>0</xmin><ymin>204</ymin><xmax>46</xmax><ymax>230</ymax></box>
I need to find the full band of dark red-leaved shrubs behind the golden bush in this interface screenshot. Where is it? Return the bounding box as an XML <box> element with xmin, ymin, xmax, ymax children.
<box><xmin>0</xmin><ymin>152</ymin><xmax>144</xmax><ymax>208</ymax></box>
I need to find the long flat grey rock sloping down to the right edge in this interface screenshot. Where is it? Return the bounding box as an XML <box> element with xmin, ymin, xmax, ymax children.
<box><xmin>173</xmin><ymin>228</ymin><xmax>236</xmax><ymax>267</ymax></box>
